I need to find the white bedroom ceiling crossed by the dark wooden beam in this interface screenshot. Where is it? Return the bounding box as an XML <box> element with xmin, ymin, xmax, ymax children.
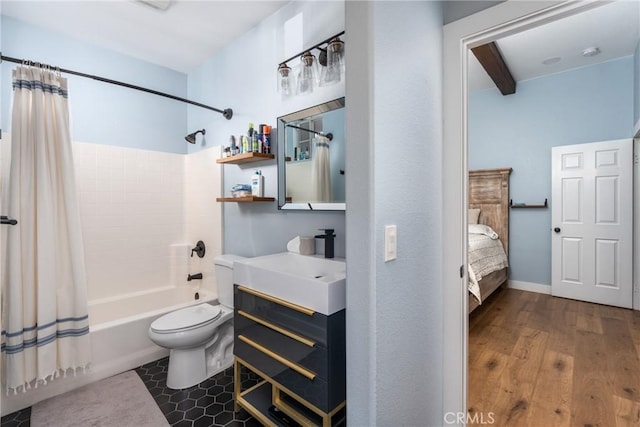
<box><xmin>469</xmin><ymin>0</ymin><xmax>640</xmax><ymax>93</ymax></box>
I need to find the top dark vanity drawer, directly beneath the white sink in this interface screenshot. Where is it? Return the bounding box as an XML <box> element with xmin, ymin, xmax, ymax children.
<box><xmin>234</xmin><ymin>285</ymin><xmax>345</xmax><ymax>347</ymax></box>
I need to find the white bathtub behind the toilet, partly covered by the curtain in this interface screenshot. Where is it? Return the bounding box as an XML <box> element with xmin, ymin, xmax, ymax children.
<box><xmin>1</xmin><ymin>286</ymin><xmax>217</xmax><ymax>416</ymax></box>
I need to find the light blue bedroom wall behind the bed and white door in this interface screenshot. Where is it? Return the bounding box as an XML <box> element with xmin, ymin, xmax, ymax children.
<box><xmin>469</xmin><ymin>56</ymin><xmax>636</xmax><ymax>285</ymax></box>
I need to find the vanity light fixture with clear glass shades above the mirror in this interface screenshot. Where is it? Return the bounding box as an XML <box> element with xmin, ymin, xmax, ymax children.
<box><xmin>278</xmin><ymin>31</ymin><xmax>344</xmax><ymax>98</ymax></box>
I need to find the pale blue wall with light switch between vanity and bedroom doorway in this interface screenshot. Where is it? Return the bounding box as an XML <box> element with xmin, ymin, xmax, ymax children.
<box><xmin>346</xmin><ymin>1</ymin><xmax>447</xmax><ymax>426</ymax></box>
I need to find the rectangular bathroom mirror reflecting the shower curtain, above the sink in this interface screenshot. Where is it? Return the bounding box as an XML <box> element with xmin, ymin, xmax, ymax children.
<box><xmin>277</xmin><ymin>97</ymin><xmax>346</xmax><ymax>210</ymax></box>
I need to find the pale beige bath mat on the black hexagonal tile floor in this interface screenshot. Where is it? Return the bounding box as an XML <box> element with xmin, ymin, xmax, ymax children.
<box><xmin>31</xmin><ymin>371</ymin><xmax>169</xmax><ymax>427</ymax></box>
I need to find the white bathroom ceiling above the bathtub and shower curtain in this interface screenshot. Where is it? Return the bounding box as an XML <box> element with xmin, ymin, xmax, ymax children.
<box><xmin>0</xmin><ymin>0</ymin><xmax>288</xmax><ymax>73</ymax></box>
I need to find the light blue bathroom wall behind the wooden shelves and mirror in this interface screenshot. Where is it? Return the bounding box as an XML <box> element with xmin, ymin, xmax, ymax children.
<box><xmin>188</xmin><ymin>1</ymin><xmax>349</xmax><ymax>257</ymax></box>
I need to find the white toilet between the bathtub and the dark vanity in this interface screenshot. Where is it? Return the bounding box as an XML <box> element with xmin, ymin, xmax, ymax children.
<box><xmin>149</xmin><ymin>254</ymin><xmax>244</xmax><ymax>389</ymax></box>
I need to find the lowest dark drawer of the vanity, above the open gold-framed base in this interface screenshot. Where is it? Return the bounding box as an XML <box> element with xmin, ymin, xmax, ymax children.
<box><xmin>234</xmin><ymin>334</ymin><xmax>346</xmax><ymax>413</ymax></box>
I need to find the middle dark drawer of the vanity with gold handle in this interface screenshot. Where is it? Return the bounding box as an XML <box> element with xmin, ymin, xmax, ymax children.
<box><xmin>234</xmin><ymin>310</ymin><xmax>329</xmax><ymax>380</ymax></box>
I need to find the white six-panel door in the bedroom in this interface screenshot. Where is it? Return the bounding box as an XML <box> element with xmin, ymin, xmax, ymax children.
<box><xmin>551</xmin><ymin>139</ymin><xmax>633</xmax><ymax>308</ymax></box>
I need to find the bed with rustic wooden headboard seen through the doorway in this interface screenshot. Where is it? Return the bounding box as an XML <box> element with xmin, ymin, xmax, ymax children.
<box><xmin>469</xmin><ymin>168</ymin><xmax>511</xmax><ymax>313</ymax></box>
